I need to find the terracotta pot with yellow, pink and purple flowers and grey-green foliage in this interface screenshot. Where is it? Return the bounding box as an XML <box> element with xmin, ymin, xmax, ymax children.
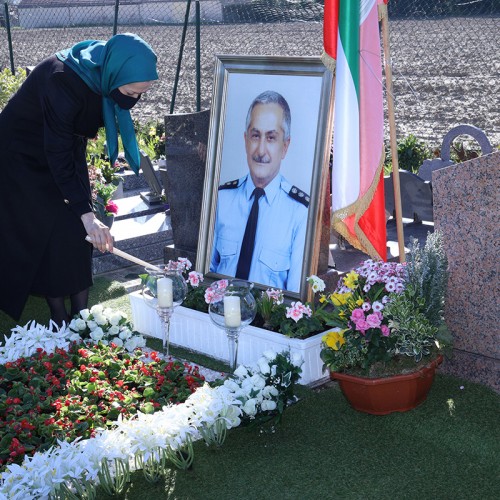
<box><xmin>321</xmin><ymin>232</ymin><xmax>451</xmax><ymax>414</ymax></box>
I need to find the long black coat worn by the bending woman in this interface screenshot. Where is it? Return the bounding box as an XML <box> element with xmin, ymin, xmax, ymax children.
<box><xmin>0</xmin><ymin>57</ymin><xmax>103</xmax><ymax>319</ymax></box>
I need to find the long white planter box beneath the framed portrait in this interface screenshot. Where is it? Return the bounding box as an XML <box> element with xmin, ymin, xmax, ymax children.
<box><xmin>129</xmin><ymin>291</ymin><xmax>328</xmax><ymax>385</ymax></box>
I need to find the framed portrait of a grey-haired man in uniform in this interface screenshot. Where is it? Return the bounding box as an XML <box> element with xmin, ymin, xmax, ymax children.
<box><xmin>196</xmin><ymin>55</ymin><xmax>333</xmax><ymax>300</ymax></box>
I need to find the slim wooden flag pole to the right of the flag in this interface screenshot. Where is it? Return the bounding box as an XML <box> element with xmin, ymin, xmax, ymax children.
<box><xmin>378</xmin><ymin>3</ymin><xmax>406</xmax><ymax>262</ymax></box>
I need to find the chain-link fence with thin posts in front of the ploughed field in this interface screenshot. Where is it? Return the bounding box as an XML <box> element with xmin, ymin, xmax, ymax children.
<box><xmin>0</xmin><ymin>0</ymin><xmax>500</xmax><ymax>146</ymax></box>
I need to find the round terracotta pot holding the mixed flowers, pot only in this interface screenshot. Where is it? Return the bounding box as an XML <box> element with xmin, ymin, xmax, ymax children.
<box><xmin>330</xmin><ymin>355</ymin><xmax>443</xmax><ymax>415</ymax></box>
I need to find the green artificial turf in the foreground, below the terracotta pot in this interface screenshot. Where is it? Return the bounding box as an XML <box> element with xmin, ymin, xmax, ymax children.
<box><xmin>98</xmin><ymin>375</ymin><xmax>500</xmax><ymax>500</ymax></box>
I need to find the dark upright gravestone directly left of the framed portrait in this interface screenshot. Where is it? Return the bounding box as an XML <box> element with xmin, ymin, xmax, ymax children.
<box><xmin>160</xmin><ymin>110</ymin><xmax>210</xmax><ymax>265</ymax></box>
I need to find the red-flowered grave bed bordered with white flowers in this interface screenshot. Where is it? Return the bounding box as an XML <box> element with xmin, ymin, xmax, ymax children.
<box><xmin>0</xmin><ymin>314</ymin><xmax>302</xmax><ymax>500</ymax></box>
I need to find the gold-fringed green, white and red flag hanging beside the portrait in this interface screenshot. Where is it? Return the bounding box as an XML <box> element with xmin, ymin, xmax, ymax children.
<box><xmin>323</xmin><ymin>0</ymin><xmax>387</xmax><ymax>260</ymax></box>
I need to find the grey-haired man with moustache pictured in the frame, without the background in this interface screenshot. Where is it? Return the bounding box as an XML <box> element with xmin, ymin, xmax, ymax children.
<box><xmin>210</xmin><ymin>90</ymin><xmax>310</xmax><ymax>292</ymax></box>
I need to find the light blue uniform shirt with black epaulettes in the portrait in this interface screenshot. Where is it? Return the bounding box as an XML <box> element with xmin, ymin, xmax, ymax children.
<box><xmin>210</xmin><ymin>174</ymin><xmax>309</xmax><ymax>292</ymax></box>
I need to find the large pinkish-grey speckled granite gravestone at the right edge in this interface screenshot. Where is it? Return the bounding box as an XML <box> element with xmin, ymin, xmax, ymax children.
<box><xmin>432</xmin><ymin>152</ymin><xmax>500</xmax><ymax>392</ymax></box>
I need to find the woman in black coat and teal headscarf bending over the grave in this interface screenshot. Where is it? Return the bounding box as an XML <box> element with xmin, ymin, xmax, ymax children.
<box><xmin>0</xmin><ymin>34</ymin><xmax>158</xmax><ymax>325</ymax></box>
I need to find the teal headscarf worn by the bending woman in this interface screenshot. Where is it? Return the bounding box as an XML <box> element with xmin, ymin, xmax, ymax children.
<box><xmin>56</xmin><ymin>33</ymin><xmax>158</xmax><ymax>174</ymax></box>
